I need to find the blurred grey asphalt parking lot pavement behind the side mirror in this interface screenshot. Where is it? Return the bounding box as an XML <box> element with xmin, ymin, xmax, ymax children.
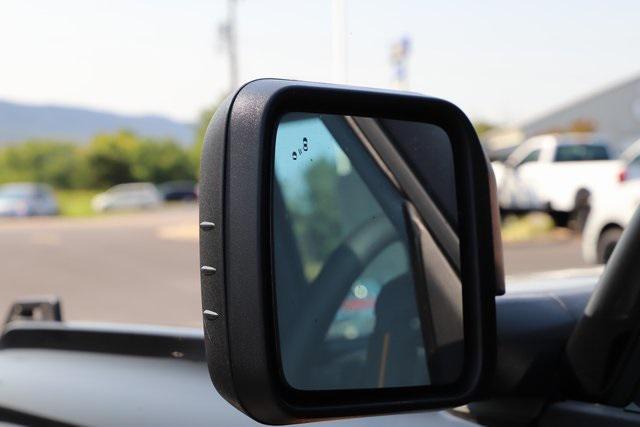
<box><xmin>0</xmin><ymin>205</ymin><xmax>583</xmax><ymax>327</ymax></box>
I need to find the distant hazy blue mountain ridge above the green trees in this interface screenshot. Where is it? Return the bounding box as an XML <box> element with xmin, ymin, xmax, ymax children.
<box><xmin>0</xmin><ymin>100</ymin><xmax>194</xmax><ymax>146</ymax></box>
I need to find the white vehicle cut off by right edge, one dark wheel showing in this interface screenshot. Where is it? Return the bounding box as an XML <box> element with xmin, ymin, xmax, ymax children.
<box><xmin>582</xmin><ymin>141</ymin><xmax>640</xmax><ymax>264</ymax></box>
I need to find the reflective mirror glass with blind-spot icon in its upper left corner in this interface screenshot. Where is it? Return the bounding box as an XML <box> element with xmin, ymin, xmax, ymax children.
<box><xmin>272</xmin><ymin>113</ymin><xmax>464</xmax><ymax>390</ymax></box>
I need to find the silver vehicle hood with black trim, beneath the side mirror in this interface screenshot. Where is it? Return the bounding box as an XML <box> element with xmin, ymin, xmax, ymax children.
<box><xmin>0</xmin><ymin>322</ymin><xmax>475</xmax><ymax>427</ymax></box>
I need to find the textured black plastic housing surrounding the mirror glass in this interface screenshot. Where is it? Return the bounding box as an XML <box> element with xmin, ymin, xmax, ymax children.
<box><xmin>200</xmin><ymin>79</ymin><xmax>504</xmax><ymax>424</ymax></box>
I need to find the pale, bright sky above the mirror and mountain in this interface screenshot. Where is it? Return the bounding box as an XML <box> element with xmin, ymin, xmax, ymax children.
<box><xmin>0</xmin><ymin>0</ymin><xmax>640</xmax><ymax>125</ymax></box>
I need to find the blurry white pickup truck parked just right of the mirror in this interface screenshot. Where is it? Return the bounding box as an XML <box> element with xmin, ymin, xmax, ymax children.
<box><xmin>493</xmin><ymin>134</ymin><xmax>623</xmax><ymax>225</ymax></box>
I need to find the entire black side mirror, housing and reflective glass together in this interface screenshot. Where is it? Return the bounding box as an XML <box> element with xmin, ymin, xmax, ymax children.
<box><xmin>200</xmin><ymin>80</ymin><xmax>504</xmax><ymax>424</ymax></box>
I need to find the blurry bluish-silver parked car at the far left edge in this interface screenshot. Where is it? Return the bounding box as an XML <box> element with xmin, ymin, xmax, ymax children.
<box><xmin>0</xmin><ymin>183</ymin><xmax>60</xmax><ymax>217</ymax></box>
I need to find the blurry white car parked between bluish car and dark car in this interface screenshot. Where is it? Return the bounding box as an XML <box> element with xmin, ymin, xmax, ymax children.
<box><xmin>91</xmin><ymin>182</ymin><xmax>163</xmax><ymax>212</ymax></box>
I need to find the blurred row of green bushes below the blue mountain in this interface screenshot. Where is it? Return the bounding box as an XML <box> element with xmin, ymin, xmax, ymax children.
<box><xmin>0</xmin><ymin>131</ymin><xmax>196</xmax><ymax>189</ymax></box>
